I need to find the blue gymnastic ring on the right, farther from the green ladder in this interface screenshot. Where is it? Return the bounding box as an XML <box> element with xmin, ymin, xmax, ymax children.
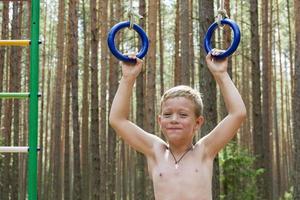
<box><xmin>204</xmin><ymin>18</ymin><xmax>241</xmax><ymax>58</ymax></box>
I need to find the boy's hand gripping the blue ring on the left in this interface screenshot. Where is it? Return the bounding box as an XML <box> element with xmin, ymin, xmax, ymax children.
<box><xmin>121</xmin><ymin>55</ymin><xmax>143</xmax><ymax>80</ymax></box>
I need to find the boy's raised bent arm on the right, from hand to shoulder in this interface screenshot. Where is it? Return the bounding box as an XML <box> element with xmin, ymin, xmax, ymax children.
<box><xmin>202</xmin><ymin>51</ymin><xmax>246</xmax><ymax>158</ymax></box>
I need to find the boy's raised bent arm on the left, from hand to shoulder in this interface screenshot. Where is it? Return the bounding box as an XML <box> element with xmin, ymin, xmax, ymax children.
<box><xmin>109</xmin><ymin>56</ymin><xmax>162</xmax><ymax>156</ymax></box>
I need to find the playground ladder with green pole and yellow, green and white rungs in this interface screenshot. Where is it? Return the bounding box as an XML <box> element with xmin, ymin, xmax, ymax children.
<box><xmin>0</xmin><ymin>0</ymin><xmax>40</xmax><ymax>200</ymax></box>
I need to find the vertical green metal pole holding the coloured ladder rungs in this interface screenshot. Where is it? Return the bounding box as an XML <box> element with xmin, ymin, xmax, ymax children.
<box><xmin>28</xmin><ymin>0</ymin><xmax>40</xmax><ymax>200</ymax></box>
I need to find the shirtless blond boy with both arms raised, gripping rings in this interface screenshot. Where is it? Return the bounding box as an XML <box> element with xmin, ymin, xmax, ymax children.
<box><xmin>109</xmin><ymin>50</ymin><xmax>246</xmax><ymax>200</ymax></box>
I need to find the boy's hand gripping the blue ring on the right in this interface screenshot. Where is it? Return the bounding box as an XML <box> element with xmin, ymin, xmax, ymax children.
<box><xmin>206</xmin><ymin>49</ymin><xmax>228</xmax><ymax>76</ymax></box>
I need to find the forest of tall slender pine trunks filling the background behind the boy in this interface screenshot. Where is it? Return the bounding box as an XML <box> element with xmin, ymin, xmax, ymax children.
<box><xmin>0</xmin><ymin>0</ymin><xmax>300</xmax><ymax>200</ymax></box>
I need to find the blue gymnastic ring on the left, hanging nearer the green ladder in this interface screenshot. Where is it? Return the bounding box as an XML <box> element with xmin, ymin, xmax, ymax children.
<box><xmin>107</xmin><ymin>21</ymin><xmax>149</xmax><ymax>62</ymax></box>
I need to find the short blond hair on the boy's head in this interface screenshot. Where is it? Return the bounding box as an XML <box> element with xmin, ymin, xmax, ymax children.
<box><xmin>160</xmin><ymin>85</ymin><xmax>203</xmax><ymax>117</ymax></box>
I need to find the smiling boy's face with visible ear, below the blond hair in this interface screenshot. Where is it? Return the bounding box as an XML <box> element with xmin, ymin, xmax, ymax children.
<box><xmin>158</xmin><ymin>97</ymin><xmax>204</xmax><ymax>142</ymax></box>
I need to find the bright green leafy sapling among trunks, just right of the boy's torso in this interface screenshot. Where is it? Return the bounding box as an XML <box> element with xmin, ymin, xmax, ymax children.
<box><xmin>220</xmin><ymin>142</ymin><xmax>264</xmax><ymax>200</ymax></box>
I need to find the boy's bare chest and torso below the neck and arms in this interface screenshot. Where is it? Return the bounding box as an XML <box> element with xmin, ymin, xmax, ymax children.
<box><xmin>148</xmin><ymin>142</ymin><xmax>213</xmax><ymax>200</ymax></box>
